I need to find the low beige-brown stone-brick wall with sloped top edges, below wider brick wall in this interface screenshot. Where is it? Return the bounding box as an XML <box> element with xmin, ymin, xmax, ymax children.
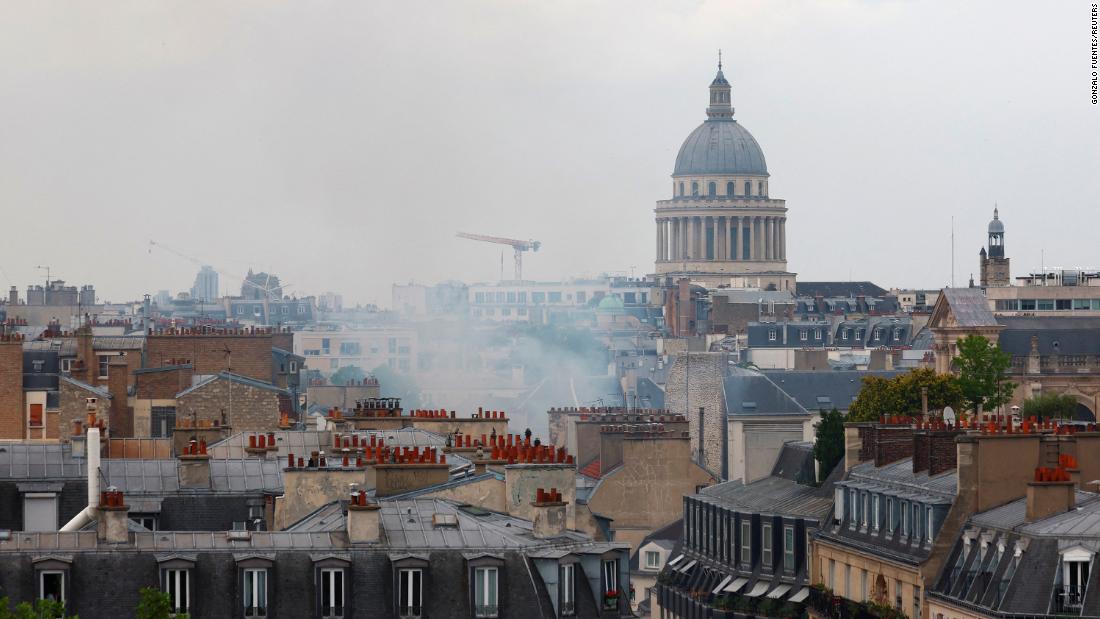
<box><xmin>176</xmin><ymin>378</ymin><xmax>279</xmax><ymax>432</ymax></box>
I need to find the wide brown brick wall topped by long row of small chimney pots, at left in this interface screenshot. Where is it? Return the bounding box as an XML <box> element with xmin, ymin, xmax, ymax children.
<box><xmin>145</xmin><ymin>333</ymin><xmax>273</xmax><ymax>382</ymax></box>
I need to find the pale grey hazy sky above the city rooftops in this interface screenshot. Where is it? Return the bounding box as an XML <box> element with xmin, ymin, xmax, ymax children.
<box><xmin>0</xmin><ymin>0</ymin><xmax>1100</xmax><ymax>305</ymax></box>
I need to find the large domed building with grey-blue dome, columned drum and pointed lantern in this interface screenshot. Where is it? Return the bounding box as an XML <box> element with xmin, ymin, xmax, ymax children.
<box><xmin>656</xmin><ymin>62</ymin><xmax>794</xmax><ymax>290</ymax></box>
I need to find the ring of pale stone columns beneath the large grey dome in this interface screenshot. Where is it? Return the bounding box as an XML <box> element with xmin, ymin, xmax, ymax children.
<box><xmin>657</xmin><ymin>215</ymin><xmax>787</xmax><ymax>262</ymax></box>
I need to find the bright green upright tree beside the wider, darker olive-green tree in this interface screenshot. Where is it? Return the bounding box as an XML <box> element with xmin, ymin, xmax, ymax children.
<box><xmin>954</xmin><ymin>335</ymin><xmax>1015</xmax><ymax>412</ymax></box>
